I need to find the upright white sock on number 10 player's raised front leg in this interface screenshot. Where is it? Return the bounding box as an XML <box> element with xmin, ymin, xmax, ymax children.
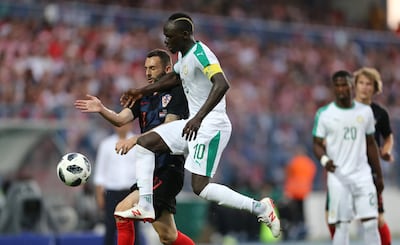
<box><xmin>133</xmin><ymin>145</ymin><xmax>155</xmax><ymax>209</ymax></box>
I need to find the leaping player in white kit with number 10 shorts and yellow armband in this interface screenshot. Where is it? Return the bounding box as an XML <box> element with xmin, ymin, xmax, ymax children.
<box><xmin>115</xmin><ymin>13</ymin><xmax>280</xmax><ymax>237</ymax></box>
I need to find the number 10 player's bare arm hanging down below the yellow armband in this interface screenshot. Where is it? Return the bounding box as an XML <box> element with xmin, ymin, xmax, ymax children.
<box><xmin>182</xmin><ymin>72</ymin><xmax>230</xmax><ymax>141</ymax></box>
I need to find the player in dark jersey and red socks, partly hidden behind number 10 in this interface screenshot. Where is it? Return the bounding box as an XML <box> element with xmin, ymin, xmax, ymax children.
<box><xmin>75</xmin><ymin>50</ymin><xmax>194</xmax><ymax>245</ymax></box>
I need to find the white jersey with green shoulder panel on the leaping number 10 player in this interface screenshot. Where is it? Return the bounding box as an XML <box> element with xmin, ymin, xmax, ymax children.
<box><xmin>174</xmin><ymin>41</ymin><xmax>226</xmax><ymax>117</ymax></box>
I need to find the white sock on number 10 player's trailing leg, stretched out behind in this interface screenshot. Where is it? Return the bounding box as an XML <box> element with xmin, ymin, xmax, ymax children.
<box><xmin>199</xmin><ymin>183</ymin><xmax>254</xmax><ymax>212</ymax></box>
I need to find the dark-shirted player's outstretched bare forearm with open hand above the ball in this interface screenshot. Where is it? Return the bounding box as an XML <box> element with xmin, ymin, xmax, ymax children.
<box><xmin>74</xmin><ymin>94</ymin><xmax>133</xmax><ymax>127</ymax></box>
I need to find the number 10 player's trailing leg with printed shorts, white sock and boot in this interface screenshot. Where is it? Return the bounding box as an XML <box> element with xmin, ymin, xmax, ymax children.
<box><xmin>185</xmin><ymin>124</ymin><xmax>280</xmax><ymax>237</ymax></box>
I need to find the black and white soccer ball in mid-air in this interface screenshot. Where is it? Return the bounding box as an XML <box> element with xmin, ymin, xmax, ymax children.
<box><xmin>57</xmin><ymin>152</ymin><xmax>92</xmax><ymax>186</ymax></box>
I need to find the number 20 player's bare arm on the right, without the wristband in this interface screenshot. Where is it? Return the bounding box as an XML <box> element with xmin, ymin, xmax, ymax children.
<box><xmin>366</xmin><ymin>135</ymin><xmax>384</xmax><ymax>193</ymax></box>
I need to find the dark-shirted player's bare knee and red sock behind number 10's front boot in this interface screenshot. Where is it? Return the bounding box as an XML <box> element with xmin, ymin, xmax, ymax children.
<box><xmin>115</xmin><ymin>191</ymin><xmax>139</xmax><ymax>245</ymax></box>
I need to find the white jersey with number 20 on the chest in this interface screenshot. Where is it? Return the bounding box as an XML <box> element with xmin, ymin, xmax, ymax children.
<box><xmin>313</xmin><ymin>101</ymin><xmax>375</xmax><ymax>182</ymax></box>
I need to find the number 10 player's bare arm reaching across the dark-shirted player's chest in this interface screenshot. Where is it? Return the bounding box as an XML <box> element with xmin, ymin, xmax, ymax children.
<box><xmin>120</xmin><ymin>72</ymin><xmax>181</xmax><ymax>108</ymax></box>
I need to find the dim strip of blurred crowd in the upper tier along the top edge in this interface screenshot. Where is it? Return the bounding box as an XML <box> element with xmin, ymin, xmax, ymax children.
<box><xmin>19</xmin><ymin>0</ymin><xmax>386</xmax><ymax>30</ymax></box>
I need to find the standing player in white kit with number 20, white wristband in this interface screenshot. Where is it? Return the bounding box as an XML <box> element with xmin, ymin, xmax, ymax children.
<box><xmin>313</xmin><ymin>71</ymin><xmax>383</xmax><ymax>245</ymax></box>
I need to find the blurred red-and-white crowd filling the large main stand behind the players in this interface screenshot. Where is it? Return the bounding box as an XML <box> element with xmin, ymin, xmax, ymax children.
<box><xmin>0</xmin><ymin>0</ymin><xmax>400</xmax><ymax>199</ymax></box>
